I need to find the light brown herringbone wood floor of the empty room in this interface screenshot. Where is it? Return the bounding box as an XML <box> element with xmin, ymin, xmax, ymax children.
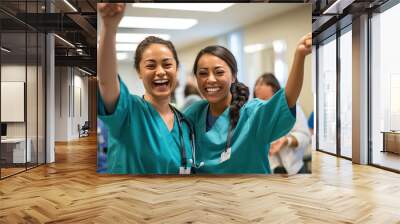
<box><xmin>0</xmin><ymin>137</ymin><xmax>400</xmax><ymax>224</ymax></box>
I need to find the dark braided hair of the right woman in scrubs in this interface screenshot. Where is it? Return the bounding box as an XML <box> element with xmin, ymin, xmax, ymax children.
<box><xmin>193</xmin><ymin>45</ymin><xmax>249</xmax><ymax>128</ymax></box>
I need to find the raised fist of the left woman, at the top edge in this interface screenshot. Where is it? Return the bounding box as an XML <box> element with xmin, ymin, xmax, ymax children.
<box><xmin>97</xmin><ymin>3</ymin><xmax>125</xmax><ymax>32</ymax></box>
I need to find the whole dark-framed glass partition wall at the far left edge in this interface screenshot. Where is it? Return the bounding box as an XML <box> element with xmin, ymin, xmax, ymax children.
<box><xmin>0</xmin><ymin>0</ymin><xmax>46</xmax><ymax>178</ymax></box>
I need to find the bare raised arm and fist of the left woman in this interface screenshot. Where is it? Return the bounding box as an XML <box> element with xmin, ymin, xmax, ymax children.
<box><xmin>97</xmin><ymin>3</ymin><xmax>125</xmax><ymax>113</ymax></box>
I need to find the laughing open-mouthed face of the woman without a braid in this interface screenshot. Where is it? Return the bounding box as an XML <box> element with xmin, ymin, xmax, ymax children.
<box><xmin>139</xmin><ymin>44</ymin><xmax>177</xmax><ymax>100</ymax></box>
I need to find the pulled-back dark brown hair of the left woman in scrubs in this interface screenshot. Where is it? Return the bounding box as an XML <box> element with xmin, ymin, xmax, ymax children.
<box><xmin>135</xmin><ymin>36</ymin><xmax>179</xmax><ymax>72</ymax></box>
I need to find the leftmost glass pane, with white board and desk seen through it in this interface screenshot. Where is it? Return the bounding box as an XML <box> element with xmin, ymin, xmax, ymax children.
<box><xmin>0</xmin><ymin>33</ymin><xmax>30</xmax><ymax>177</ymax></box>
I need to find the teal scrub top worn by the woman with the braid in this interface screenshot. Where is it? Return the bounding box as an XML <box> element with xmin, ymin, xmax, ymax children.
<box><xmin>184</xmin><ymin>89</ymin><xmax>296</xmax><ymax>174</ymax></box>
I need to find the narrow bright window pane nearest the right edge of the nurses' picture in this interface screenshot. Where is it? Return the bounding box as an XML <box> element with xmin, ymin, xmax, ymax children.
<box><xmin>318</xmin><ymin>39</ymin><xmax>336</xmax><ymax>153</ymax></box>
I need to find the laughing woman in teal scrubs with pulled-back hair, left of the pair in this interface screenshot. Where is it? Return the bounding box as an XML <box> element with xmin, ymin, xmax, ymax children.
<box><xmin>97</xmin><ymin>3</ymin><xmax>192</xmax><ymax>174</ymax></box>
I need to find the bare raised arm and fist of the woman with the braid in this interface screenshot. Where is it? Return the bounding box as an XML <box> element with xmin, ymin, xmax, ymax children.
<box><xmin>285</xmin><ymin>33</ymin><xmax>312</xmax><ymax>108</ymax></box>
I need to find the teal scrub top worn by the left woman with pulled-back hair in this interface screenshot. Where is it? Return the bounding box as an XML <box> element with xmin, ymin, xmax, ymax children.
<box><xmin>97</xmin><ymin>80</ymin><xmax>192</xmax><ymax>174</ymax></box>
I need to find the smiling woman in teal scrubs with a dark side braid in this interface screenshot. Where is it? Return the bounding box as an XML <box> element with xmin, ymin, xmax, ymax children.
<box><xmin>184</xmin><ymin>34</ymin><xmax>311</xmax><ymax>174</ymax></box>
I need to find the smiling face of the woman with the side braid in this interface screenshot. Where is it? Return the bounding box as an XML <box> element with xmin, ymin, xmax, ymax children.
<box><xmin>196</xmin><ymin>54</ymin><xmax>235</xmax><ymax>104</ymax></box>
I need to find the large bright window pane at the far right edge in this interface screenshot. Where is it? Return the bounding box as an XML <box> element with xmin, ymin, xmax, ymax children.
<box><xmin>371</xmin><ymin>4</ymin><xmax>400</xmax><ymax>170</ymax></box>
